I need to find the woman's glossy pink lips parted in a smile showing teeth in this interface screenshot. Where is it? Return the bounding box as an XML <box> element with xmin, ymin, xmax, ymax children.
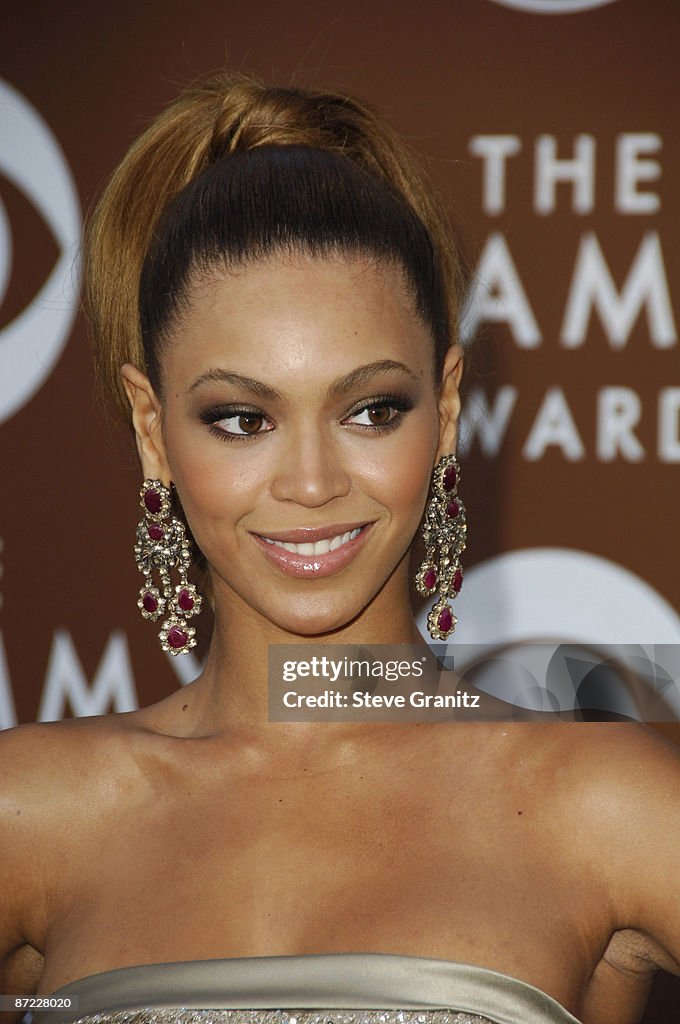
<box><xmin>252</xmin><ymin>523</ymin><xmax>373</xmax><ymax>578</ymax></box>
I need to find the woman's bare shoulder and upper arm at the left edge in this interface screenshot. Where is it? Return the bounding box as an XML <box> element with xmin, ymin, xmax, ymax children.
<box><xmin>0</xmin><ymin>715</ymin><xmax>153</xmax><ymax>994</ymax></box>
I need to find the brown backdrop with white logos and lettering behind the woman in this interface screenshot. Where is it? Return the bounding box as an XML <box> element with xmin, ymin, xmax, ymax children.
<box><xmin>0</xmin><ymin>0</ymin><xmax>680</xmax><ymax>1021</ymax></box>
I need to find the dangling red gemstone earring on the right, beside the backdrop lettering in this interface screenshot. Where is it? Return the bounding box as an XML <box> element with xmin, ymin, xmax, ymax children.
<box><xmin>416</xmin><ymin>455</ymin><xmax>467</xmax><ymax>640</ymax></box>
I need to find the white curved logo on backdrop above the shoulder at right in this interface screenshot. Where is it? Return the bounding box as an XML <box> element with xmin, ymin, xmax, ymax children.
<box><xmin>418</xmin><ymin>548</ymin><xmax>680</xmax><ymax>721</ymax></box>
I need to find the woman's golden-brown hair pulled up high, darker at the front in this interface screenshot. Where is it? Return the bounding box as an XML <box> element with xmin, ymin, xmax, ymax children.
<box><xmin>85</xmin><ymin>74</ymin><xmax>462</xmax><ymax>412</ymax></box>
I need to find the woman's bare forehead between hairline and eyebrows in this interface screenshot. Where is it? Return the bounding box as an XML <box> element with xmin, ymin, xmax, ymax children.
<box><xmin>163</xmin><ymin>257</ymin><xmax>433</xmax><ymax>387</ymax></box>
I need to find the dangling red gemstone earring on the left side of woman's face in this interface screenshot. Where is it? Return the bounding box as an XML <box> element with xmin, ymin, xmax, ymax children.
<box><xmin>134</xmin><ymin>480</ymin><xmax>203</xmax><ymax>654</ymax></box>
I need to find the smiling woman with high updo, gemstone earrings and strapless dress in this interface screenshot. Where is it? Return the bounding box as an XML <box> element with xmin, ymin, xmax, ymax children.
<box><xmin>0</xmin><ymin>76</ymin><xmax>680</xmax><ymax>1024</ymax></box>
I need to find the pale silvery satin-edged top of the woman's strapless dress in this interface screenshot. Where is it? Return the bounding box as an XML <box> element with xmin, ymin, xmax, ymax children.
<box><xmin>33</xmin><ymin>953</ymin><xmax>579</xmax><ymax>1024</ymax></box>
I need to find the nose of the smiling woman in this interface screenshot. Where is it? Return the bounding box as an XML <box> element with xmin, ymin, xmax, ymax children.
<box><xmin>271</xmin><ymin>431</ymin><xmax>351</xmax><ymax>508</ymax></box>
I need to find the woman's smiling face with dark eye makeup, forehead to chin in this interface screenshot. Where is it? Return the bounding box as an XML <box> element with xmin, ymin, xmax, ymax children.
<box><xmin>140</xmin><ymin>258</ymin><xmax>456</xmax><ymax>636</ymax></box>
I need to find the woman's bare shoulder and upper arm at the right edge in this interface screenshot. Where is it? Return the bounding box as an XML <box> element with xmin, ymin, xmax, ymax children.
<box><xmin>540</xmin><ymin>723</ymin><xmax>680</xmax><ymax>974</ymax></box>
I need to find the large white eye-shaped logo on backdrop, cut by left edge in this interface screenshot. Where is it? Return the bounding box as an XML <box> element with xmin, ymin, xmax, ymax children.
<box><xmin>0</xmin><ymin>80</ymin><xmax>81</xmax><ymax>423</ymax></box>
